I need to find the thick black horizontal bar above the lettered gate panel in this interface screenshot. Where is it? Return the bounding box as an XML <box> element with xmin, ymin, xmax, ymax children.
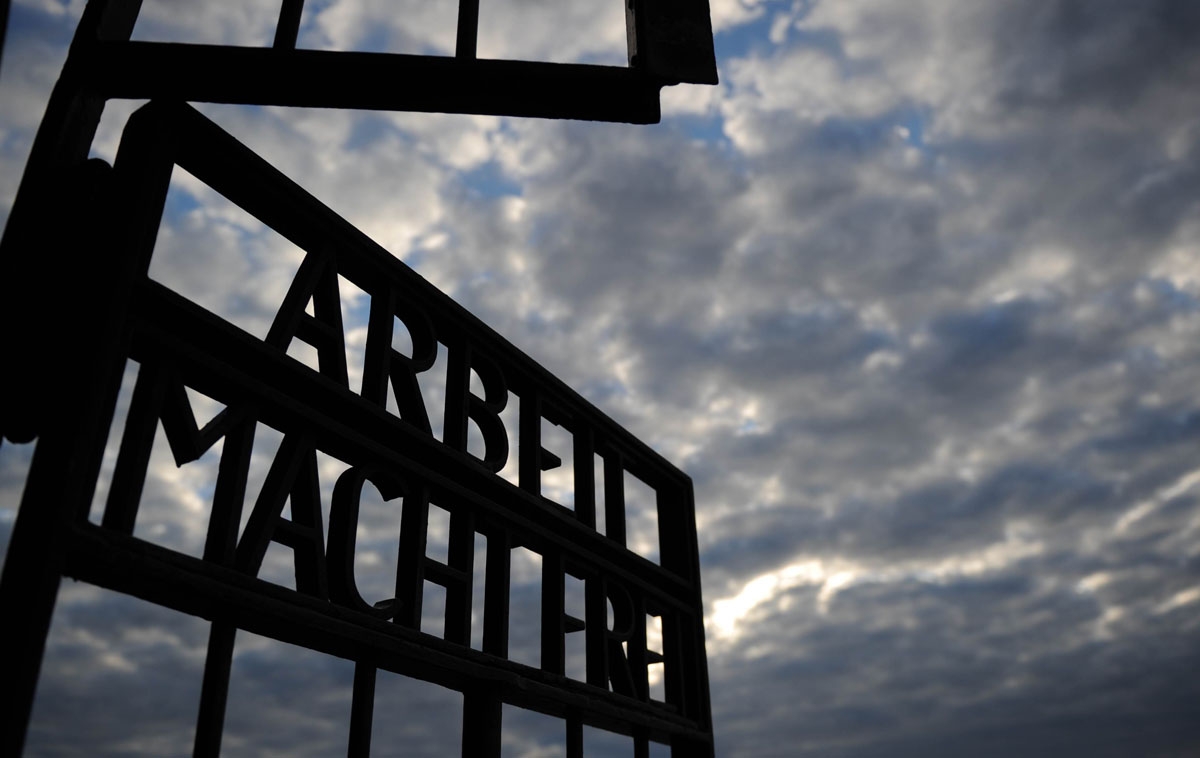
<box><xmin>86</xmin><ymin>42</ymin><xmax>661</xmax><ymax>124</ymax></box>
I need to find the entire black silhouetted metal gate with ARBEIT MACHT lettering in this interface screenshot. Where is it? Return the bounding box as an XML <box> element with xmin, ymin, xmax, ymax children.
<box><xmin>0</xmin><ymin>0</ymin><xmax>715</xmax><ymax>757</ymax></box>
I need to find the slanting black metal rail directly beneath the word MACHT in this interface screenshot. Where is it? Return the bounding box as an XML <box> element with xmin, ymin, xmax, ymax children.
<box><xmin>64</xmin><ymin>524</ymin><xmax>712</xmax><ymax>742</ymax></box>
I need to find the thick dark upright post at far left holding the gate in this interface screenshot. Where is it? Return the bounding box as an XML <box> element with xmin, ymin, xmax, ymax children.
<box><xmin>0</xmin><ymin>19</ymin><xmax>148</xmax><ymax>756</ymax></box>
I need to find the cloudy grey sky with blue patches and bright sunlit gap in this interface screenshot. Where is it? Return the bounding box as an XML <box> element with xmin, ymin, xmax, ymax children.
<box><xmin>0</xmin><ymin>0</ymin><xmax>1200</xmax><ymax>758</ymax></box>
